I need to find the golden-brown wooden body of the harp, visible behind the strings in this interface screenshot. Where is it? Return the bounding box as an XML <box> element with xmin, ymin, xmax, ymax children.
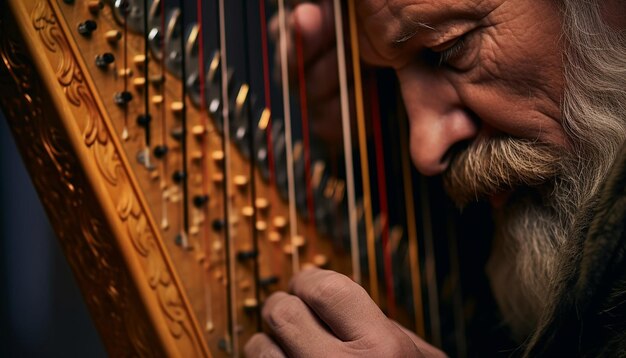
<box><xmin>0</xmin><ymin>0</ymin><xmax>350</xmax><ymax>357</ymax></box>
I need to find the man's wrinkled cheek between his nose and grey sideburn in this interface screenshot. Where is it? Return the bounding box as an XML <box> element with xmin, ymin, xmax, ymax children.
<box><xmin>454</xmin><ymin>4</ymin><xmax>565</xmax><ymax>144</ymax></box>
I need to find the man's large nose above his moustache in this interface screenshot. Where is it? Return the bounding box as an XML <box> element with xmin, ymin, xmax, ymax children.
<box><xmin>397</xmin><ymin>64</ymin><xmax>478</xmax><ymax>176</ymax></box>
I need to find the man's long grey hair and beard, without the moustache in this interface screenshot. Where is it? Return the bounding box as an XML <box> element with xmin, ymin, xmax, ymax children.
<box><xmin>480</xmin><ymin>0</ymin><xmax>626</xmax><ymax>340</ymax></box>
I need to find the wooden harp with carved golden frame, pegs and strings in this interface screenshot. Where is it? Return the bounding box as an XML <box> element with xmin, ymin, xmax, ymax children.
<box><xmin>0</xmin><ymin>0</ymin><xmax>478</xmax><ymax>357</ymax></box>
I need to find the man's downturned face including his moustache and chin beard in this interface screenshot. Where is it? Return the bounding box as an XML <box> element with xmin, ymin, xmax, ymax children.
<box><xmin>359</xmin><ymin>0</ymin><xmax>602</xmax><ymax>339</ymax></box>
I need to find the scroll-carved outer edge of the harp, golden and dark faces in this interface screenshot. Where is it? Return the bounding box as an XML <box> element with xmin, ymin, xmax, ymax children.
<box><xmin>0</xmin><ymin>1</ymin><xmax>208</xmax><ymax>356</ymax></box>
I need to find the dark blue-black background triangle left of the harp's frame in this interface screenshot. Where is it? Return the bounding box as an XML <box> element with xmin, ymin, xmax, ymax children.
<box><xmin>0</xmin><ymin>111</ymin><xmax>106</xmax><ymax>357</ymax></box>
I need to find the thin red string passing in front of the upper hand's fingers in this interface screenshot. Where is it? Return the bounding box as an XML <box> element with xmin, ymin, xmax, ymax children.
<box><xmin>295</xmin><ymin>25</ymin><xmax>315</xmax><ymax>235</ymax></box>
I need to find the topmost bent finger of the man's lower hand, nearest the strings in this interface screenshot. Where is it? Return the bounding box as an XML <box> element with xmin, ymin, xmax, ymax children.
<box><xmin>290</xmin><ymin>269</ymin><xmax>395</xmax><ymax>341</ymax></box>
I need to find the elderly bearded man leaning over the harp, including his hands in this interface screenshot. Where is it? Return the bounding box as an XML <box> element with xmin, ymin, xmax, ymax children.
<box><xmin>246</xmin><ymin>0</ymin><xmax>626</xmax><ymax>357</ymax></box>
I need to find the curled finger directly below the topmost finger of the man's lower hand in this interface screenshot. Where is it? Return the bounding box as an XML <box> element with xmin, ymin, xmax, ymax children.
<box><xmin>262</xmin><ymin>292</ymin><xmax>340</xmax><ymax>357</ymax></box>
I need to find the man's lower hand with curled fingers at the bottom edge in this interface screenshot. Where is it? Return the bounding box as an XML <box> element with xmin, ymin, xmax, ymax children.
<box><xmin>245</xmin><ymin>269</ymin><xmax>445</xmax><ymax>357</ymax></box>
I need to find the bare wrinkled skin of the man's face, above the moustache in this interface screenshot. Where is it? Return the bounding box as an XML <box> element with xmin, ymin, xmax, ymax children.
<box><xmin>359</xmin><ymin>0</ymin><xmax>567</xmax><ymax>196</ymax></box>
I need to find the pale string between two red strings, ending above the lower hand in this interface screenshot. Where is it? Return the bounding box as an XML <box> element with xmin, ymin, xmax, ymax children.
<box><xmin>278</xmin><ymin>0</ymin><xmax>300</xmax><ymax>274</ymax></box>
